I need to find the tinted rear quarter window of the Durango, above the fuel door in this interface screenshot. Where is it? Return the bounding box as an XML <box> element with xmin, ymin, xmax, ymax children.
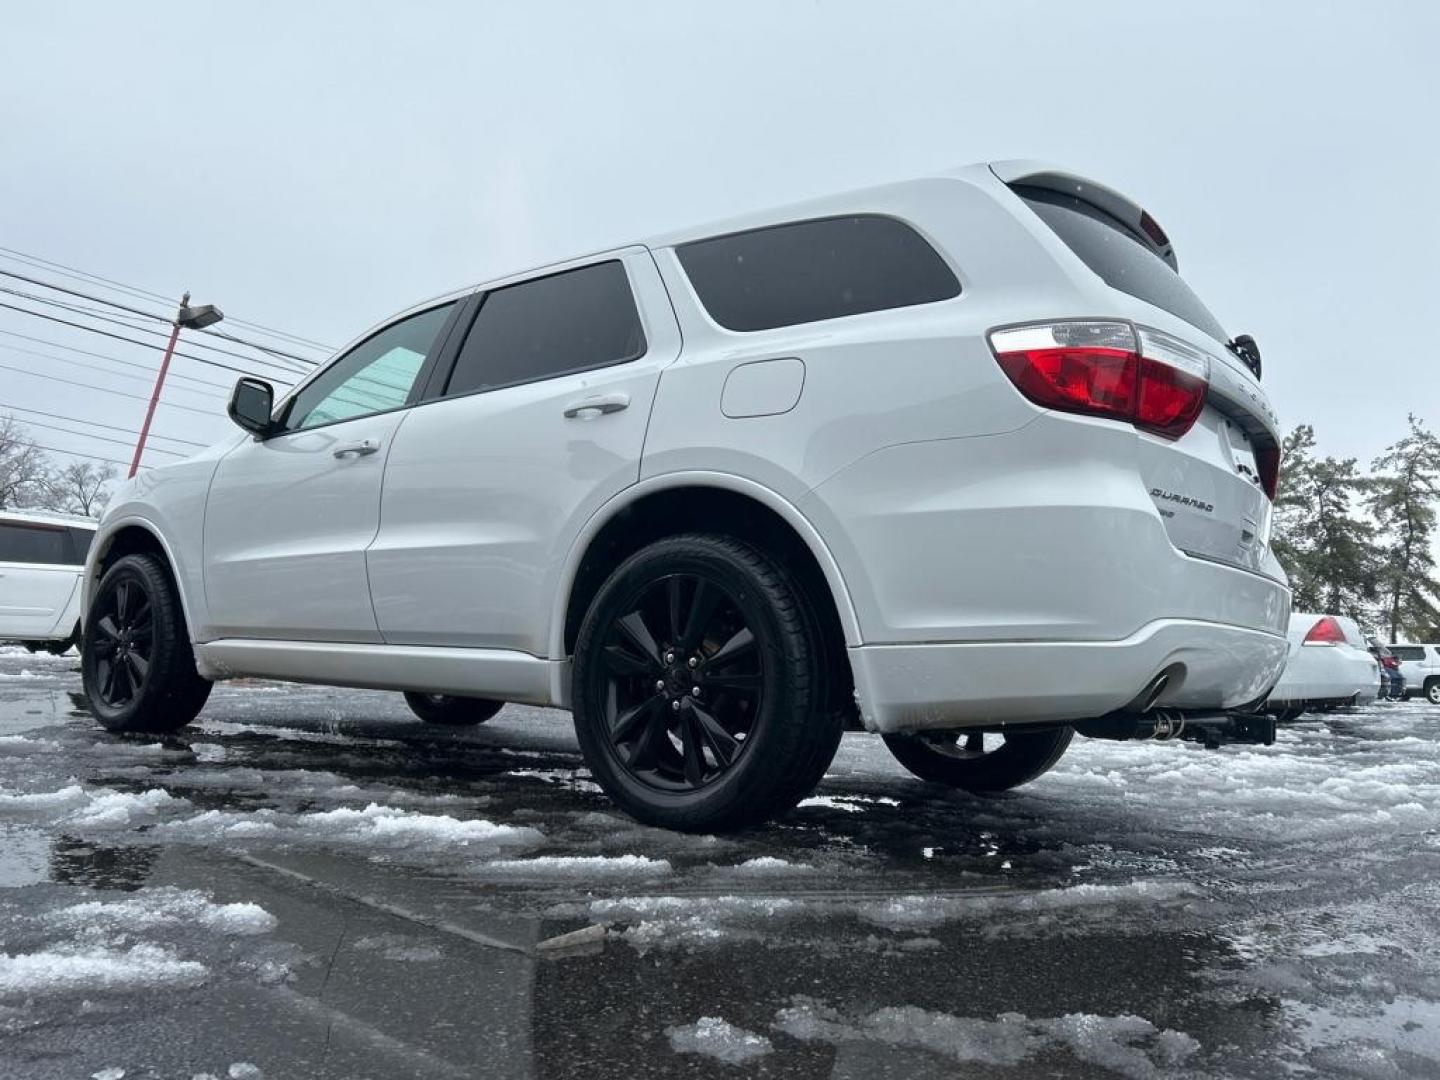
<box><xmin>675</xmin><ymin>215</ymin><xmax>960</xmax><ymax>330</ymax></box>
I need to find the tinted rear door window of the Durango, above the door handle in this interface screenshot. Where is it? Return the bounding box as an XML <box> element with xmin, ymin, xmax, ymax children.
<box><xmin>445</xmin><ymin>262</ymin><xmax>645</xmax><ymax>396</ymax></box>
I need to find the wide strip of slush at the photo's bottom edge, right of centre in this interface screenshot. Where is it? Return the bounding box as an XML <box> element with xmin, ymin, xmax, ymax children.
<box><xmin>775</xmin><ymin>996</ymin><xmax>1200</xmax><ymax>1080</ymax></box>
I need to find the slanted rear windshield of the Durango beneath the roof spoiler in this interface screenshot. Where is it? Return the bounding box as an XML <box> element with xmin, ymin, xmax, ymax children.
<box><xmin>1012</xmin><ymin>184</ymin><xmax>1227</xmax><ymax>341</ymax></box>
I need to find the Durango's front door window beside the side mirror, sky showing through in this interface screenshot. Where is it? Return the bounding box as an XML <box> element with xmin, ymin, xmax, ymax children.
<box><xmin>285</xmin><ymin>302</ymin><xmax>455</xmax><ymax>431</ymax></box>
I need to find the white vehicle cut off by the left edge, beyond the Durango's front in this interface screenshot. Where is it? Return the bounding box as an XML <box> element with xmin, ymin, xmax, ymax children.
<box><xmin>0</xmin><ymin>510</ymin><xmax>95</xmax><ymax>654</ymax></box>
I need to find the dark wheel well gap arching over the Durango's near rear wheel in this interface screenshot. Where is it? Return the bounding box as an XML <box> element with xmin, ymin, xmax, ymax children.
<box><xmin>564</xmin><ymin>487</ymin><xmax>855</xmax><ymax>728</ymax></box>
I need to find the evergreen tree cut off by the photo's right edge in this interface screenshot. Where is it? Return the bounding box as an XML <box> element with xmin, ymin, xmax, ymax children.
<box><xmin>1369</xmin><ymin>413</ymin><xmax>1440</xmax><ymax>641</ymax></box>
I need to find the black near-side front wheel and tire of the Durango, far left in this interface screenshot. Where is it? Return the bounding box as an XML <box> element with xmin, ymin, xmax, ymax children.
<box><xmin>81</xmin><ymin>554</ymin><xmax>210</xmax><ymax>733</ymax></box>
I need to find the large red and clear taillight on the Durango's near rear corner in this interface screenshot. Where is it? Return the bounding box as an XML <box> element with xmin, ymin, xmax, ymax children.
<box><xmin>989</xmin><ymin>323</ymin><xmax>1210</xmax><ymax>439</ymax></box>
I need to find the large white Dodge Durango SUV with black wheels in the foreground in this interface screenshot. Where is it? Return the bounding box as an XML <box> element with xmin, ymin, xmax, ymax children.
<box><xmin>84</xmin><ymin>163</ymin><xmax>1290</xmax><ymax>828</ymax></box>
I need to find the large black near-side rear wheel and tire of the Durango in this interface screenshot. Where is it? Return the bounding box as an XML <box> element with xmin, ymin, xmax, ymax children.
<box><xmin>572</xmin><ymin>534</ymin><xmax>844</xmax><ymax>831</ymax></box>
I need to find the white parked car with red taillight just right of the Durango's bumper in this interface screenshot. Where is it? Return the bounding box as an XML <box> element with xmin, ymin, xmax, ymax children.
<box><xmin>1266</xmin><ymin>612</ymin><xmax>1380</xmax><ymax>720</ymax></box>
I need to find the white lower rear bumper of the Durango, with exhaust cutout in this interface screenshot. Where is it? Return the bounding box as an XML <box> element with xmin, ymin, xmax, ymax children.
<box><xmin>850</xmin><ymin>619</ymin><xmax>1287</xmax><ymax>732</ymax></box>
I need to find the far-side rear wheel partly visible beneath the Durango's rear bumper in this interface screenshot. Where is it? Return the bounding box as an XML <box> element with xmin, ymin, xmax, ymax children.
<box><xmin>884</xmin><ymin>727</ymin><xmax>1074</xmax><ymax>793</ymax></box>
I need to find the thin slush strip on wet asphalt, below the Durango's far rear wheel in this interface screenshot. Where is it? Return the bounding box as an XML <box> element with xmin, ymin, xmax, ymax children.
<box><xmin>855</xmin><ymin>880</ymin><xmax>1201</xmax><ymax>930</ymax></box>
